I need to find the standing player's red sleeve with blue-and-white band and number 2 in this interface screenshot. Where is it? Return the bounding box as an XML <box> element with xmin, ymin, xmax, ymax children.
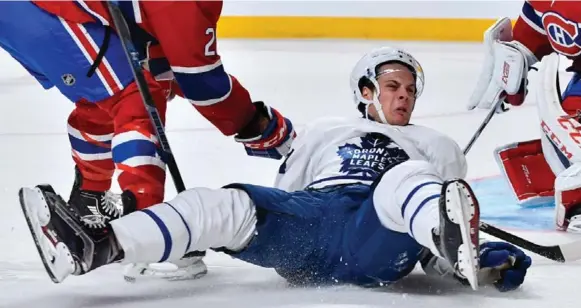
<box><xmin>141</xmin><ymin>1</ymin><xmax>256</xmax><ymax>135</ymax></box>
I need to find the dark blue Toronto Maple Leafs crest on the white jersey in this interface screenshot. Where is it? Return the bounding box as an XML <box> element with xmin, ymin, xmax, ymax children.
<box><xmin>337</xmin><ymin>133</ymin><xmax>409</xmax><ymax>178</ymax></box>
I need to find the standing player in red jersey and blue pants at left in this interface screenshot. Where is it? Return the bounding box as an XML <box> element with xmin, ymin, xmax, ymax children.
<box><xmin>0</xmin><ymin>1</ymin><xmax>295</xmax><ymax>280</ymax></box>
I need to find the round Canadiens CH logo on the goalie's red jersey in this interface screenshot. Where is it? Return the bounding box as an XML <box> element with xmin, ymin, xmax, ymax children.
<box><xmin>543</xmin><ymin>12</ymin><xmax>581</xmax><ymax>56</ymax></box>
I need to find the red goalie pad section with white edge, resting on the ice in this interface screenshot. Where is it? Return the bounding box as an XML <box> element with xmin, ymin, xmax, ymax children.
<box><xmin>494</xmin><ymin>139</ymin><xmax>555</xmax><ymax>206</ymax></box>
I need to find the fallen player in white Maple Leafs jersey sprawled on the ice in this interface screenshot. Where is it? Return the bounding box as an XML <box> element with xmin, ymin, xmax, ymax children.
<box><xmin>20</xmin><ymin>47</ymin><xmax>531</xmax><ymax>291</ymax></box>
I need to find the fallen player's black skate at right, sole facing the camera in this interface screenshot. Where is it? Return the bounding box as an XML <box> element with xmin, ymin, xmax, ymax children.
<box><xmin>434</xmin><ymin>179</ymin><xmax>480</xmax><ymax>290</ymax></box>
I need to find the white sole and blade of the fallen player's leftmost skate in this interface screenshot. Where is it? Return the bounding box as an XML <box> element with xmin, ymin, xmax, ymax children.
<box><xmin>18</xmin><ymin>188</ymin><xmax>75</xmax><ymax>283</ymax></box>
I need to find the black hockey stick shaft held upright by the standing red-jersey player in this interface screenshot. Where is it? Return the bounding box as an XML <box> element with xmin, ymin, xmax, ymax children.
<box><xmin>105</xmin><ymin>1</ymin><xmax>186</xmax><ymax>193</ymax></box>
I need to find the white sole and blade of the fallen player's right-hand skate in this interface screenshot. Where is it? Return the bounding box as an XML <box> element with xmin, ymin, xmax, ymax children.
<box><xmin>446</xmin><ymin>182</ymin><xmax>480</xmax><ymax>290</ymax></box>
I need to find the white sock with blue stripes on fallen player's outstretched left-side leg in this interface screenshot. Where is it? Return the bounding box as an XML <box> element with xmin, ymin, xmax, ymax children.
<box><xmin>111</xmin><ymin>188</ymin><xmax>256</xmax><ymax>263</ymax></box>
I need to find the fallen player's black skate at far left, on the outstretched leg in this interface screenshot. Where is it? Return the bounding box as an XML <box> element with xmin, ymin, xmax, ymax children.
<box><xmin>19</xmin><ymin>185</ymin><xmax>122</xmax><ymax>283</ymax></box>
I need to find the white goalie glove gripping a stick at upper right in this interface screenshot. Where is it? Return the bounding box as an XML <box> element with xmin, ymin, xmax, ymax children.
<box><xmin>468</xmin><ymin>17</ymin><xmax>538</xmax><ymax>112</ymax></box>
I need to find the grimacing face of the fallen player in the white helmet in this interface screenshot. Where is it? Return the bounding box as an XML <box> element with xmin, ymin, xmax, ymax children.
<box><xmin>362</xmin><ymin>63</ymin><xmax>416</xmax><ymax>125</ymax></box>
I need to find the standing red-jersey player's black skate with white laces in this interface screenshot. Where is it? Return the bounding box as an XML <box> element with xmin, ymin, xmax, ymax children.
<box><xmin>69</xmin><ymin>167</ymin><xmax>127</xmax><ymax>229</ymax></box>
